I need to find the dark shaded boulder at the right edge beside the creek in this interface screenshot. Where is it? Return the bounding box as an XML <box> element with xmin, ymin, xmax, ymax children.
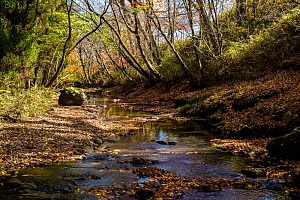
<box><xmin>267</xmin><ymin>127</ymin><xmax>300</xmax><ymax>160</ymax></box>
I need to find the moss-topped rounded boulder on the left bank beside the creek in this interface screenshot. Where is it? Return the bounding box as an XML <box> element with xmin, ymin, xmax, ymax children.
<box><xmin>58</xmin><ymin>87</ymin><xmax>86</xmax><ymax>106</ymax></box>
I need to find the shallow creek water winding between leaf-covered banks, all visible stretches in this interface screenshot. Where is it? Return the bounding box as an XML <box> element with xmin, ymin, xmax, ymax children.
<box><xmin>0</xmin><ymin>97</ymin><xmax>286</xmax><ymax>200</ymax></box>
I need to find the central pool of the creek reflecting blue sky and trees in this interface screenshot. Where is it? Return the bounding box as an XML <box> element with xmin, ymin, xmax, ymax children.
<box><xmin>108</xmin><ymin>117</ymin><xmax>250</xmax><ymax>178</ymax></box>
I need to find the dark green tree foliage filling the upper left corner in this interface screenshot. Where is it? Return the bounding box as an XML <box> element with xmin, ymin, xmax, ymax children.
<box><xmin>0</xmin><ymin>0</ymin><xmax>40</xmax><ymax>72</ymax></box>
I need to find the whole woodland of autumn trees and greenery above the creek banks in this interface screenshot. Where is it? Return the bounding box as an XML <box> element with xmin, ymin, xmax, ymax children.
<box><xmin>0</xmin><ymin>0</ymin><xmax>299</xmax><ymax>87</ymax></box>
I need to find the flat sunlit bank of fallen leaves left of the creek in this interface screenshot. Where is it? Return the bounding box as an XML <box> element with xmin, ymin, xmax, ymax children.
<box><xmin>0</xmin><ymin>105</ymin><xmax>142</xmax><ymax>176</ymax></box>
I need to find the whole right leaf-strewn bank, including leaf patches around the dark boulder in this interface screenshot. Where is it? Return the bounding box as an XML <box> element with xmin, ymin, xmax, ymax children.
<box><xmin>102</xmin><ymin>70</ymin><xmax>300</xmax><ymax>189</ymax></box>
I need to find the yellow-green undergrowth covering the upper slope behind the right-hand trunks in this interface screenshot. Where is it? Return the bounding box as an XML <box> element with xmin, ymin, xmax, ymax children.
<box><xmin>158</xmin><ymin>6</ymin><xmax>300</xmax><ymax>85</ymax></box>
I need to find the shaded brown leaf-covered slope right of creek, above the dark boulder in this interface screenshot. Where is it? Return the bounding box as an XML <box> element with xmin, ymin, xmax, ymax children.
<box><xmin>103</xmin><ymin>70</ymin><xmax>300</xmax><ymax>138</ymax></box>
